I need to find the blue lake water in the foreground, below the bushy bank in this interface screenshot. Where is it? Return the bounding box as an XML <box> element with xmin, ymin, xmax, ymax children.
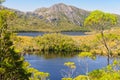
<box><xmin>25</xmin><ymin>54</ymin><xmax>118</xmax><ymax>80</ymax></box>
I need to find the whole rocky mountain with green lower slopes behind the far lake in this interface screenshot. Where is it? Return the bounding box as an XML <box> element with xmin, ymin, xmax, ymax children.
<box><xmin>0</xmin><ymin>3</ymin><xmax>120</xmax><ymax>31</ymax></box>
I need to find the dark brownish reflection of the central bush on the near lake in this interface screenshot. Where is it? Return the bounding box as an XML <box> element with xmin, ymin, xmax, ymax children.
<box><xmin>33</xmin><ymin>52</ymin><xmax>79</xmax><ymax>59</ymax></box>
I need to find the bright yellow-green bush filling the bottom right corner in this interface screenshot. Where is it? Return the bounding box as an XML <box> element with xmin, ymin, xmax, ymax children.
<box><xmin>89</xmin><ymin>60</ymin><xmax>120</xmax><ymax>80</ymax></box>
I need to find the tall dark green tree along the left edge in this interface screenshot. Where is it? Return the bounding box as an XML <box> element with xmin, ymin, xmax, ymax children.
<box><xmin>0</xmin><ymin>10</ymin><xmax>30</xmax><ymax>80</ymax></box>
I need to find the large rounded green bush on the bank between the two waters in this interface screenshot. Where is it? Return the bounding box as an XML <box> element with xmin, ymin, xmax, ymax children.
<box><xmin>36</xmin><ymin>33</ymin><xmax>79</xmax><ymax>51</ymax></box>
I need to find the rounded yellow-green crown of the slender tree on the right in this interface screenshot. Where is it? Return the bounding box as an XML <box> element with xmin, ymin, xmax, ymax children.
<box><xmin>84</xmin><ymin>10</ymin><xmax>117</xmax><ymax>31</ymax></box>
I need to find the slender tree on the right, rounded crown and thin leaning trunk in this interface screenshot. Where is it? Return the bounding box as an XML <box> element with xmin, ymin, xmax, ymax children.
<box><xmin>84</xmin><ymin>10</ymin><xmax>117</xmax><ymax>64</ymax></box>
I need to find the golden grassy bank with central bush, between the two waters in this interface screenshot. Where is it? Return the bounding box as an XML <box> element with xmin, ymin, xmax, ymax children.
<box><xmin>14</xmin><ymin>29</ymin><xmax>120</xmax><ymax>56</ymax></box>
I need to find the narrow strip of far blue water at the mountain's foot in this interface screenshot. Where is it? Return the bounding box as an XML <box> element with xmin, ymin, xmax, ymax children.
<box><xmin>18</xmin><ymin>32</ymin><xmax>86</xmax><ymax>37</ymax></box>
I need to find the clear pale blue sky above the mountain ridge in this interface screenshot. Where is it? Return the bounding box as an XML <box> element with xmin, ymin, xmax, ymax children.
<box><xmin>2</xmin><ymin>0</ymin><xmax>120</xmax><ymax>14</ymax></box>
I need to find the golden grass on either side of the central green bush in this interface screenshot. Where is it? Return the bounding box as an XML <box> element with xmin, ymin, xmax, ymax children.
<box><xmin>14</xmin><ymin>28</ymin><xmax>120</xmax><ymax>55</ymax></box>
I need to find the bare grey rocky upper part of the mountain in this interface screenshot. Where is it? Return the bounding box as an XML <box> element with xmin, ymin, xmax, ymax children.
<box><xmin>34</xmin><ymin>3</ymin><xmax>89</xmax><ymax>26</ymax></box>
